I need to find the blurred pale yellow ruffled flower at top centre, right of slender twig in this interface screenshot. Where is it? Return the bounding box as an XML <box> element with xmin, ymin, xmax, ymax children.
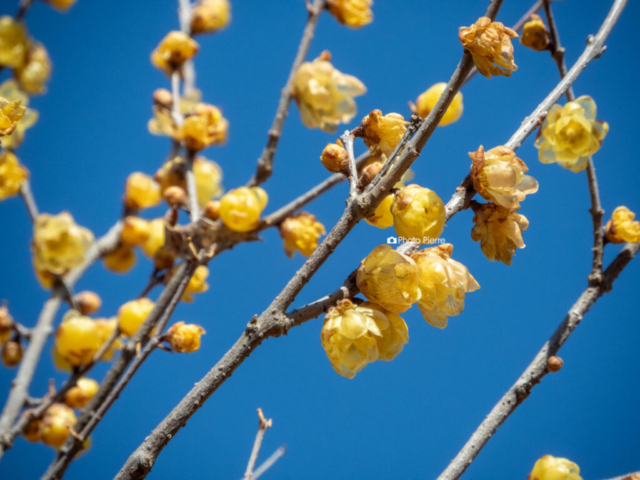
<box><xmin>293</xmin><ymin>51</ymin><xmax>367</xmax><ymax>132</ymax></box>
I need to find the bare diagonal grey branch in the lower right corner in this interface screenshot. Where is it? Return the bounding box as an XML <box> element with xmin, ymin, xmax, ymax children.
<box><xmin>438</xmin><ymin>243</ymin><xmax>640</xmax><ymax>480</ymax></box>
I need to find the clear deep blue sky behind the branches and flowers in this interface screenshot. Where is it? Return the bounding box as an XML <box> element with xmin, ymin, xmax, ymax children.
<box><xmin>0</xmin><ymin>0</ymin><xmax>640</xmax><ymax>480</ymax></box>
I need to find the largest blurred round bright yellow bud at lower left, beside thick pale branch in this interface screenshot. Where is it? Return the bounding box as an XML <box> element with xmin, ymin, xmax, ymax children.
<box><xmin>55</xmin><ymin>310</ymin><xmax>100</xmax><ymax>367</ymax></box>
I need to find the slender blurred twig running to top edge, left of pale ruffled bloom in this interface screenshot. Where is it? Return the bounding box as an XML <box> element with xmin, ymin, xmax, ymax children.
<box><xmin>248</xmin><ymin>0</ymin><xmax>325</xmax><ymax>187</ymax></box>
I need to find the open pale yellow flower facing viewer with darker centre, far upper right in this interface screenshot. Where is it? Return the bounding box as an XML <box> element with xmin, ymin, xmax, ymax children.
<box><xmin>535</xmin><ymin>95</ymin><xmax>609</xmax><ymax>172</ymax></box>
